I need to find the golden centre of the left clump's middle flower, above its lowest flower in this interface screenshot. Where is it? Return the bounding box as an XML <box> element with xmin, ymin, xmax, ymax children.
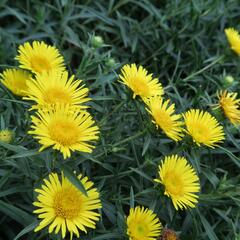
<box><xmin>44</xmin><ymin>88</ymin><xmax>71</xmax><ymax>104</ymax></box>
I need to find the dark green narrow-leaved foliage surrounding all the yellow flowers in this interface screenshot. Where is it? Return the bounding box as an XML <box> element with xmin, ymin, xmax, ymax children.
<box><xmin>0</xmin><ymin>0</ymin><xmax>240</xmax><ymax>240</ymax></box>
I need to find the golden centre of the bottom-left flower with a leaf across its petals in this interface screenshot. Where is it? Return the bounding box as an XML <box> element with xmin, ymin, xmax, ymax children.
<box><xmin>54</xmin><ymin>188</ymin><xmax>82</xmax><ymax>219</ymax></box>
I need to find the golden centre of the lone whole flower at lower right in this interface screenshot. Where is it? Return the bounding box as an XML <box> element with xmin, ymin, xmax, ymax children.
<box><xmin>165</xmin><ymin>172</ymin><xmax>184</xmax><ymax>196</ymax></box>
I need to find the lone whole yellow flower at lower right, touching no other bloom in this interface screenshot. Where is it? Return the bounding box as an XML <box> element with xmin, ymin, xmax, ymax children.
<box><xmin>155</xmin><ymin>155</ymin><xmax>200</xmax><ymax>210</ymax></box>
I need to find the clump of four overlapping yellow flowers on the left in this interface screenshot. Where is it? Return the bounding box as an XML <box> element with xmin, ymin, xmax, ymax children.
<box><xmin>1</xmin><ymin>41</ymin><xmax>99</xmax><ymax>158</ymax></box>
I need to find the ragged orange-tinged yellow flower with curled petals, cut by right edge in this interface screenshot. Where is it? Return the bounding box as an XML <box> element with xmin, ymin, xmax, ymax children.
<box><xmin>218</xmin><ymin>91</ymin><xmax>240</xmax><ymax>125</ymax></box>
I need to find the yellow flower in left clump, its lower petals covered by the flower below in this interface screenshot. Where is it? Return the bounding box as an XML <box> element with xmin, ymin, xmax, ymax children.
<box><xmin>24</xmin><ymin>71</ymin><xmax>90</xmax><ymax>108</ymax></box>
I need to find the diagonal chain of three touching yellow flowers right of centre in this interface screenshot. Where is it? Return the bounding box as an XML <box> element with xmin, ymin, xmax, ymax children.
<box><xmin>119</xmin><ymin>64</ymin><xmax>224</xmax><ymax>147</ymax></box>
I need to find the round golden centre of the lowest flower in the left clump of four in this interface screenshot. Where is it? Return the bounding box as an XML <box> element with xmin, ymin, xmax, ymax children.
<box><xmin>49</xmin><ymin>120</ymin><xmax>79</xmax><ymax>146</ymax></box>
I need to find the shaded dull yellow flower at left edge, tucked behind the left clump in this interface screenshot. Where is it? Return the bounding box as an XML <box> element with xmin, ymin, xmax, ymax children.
<box><xmin>0</xmin><ymin>69</ymin><xmax>31</xmax><ymax>96</ymax></box>
